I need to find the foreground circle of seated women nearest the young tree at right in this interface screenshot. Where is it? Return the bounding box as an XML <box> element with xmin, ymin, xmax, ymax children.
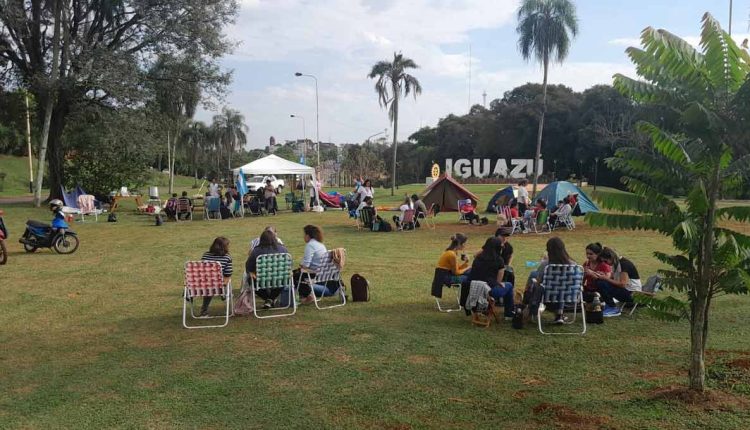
<box><xmin>432</xmin><ymin>228</ymin><xmax>642</xmax><ymax>324</ymax></box>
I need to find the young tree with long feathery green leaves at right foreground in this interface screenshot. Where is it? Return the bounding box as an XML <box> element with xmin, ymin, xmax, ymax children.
<box><xmin>588</xmin><ymin>13</ymin><xmax>750</xmax><ymax>391</ymax></box>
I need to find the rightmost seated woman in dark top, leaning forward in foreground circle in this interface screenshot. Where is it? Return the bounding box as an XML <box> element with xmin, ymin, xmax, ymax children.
<box><xmin>594</xmin><ymin>247</ymin><xmax>642</xmax><ymax>317</ymax></box>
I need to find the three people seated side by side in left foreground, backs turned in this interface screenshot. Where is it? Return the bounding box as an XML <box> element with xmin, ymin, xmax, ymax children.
<box><xmin>200</xmin><ymin>225</ymin><xmax>338</xmax><ymax>316</ymax></box>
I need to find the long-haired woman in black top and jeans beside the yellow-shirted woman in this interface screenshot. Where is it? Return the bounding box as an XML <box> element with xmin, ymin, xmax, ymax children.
<box><xmin>470</xmin><ymin>237</ymin><xmax>513</xmax><ymax>318</ymax></box>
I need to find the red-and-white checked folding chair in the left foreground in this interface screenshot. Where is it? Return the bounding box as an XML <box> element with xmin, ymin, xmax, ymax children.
<box><xmin>182</xmin><ymin>261</ymin><xmax>234</xmax><ymax>328</ymax></box>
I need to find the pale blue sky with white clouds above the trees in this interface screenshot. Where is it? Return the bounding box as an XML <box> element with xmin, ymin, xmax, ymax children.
<box><xmin>196</xmin><ymin>0</ymin><xmax>750</xmax><ymax>148</ymax></box>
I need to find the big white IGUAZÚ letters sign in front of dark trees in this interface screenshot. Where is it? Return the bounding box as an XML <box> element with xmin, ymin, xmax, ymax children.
<box><xmin>445</xmin><ymin>158</ymin><xmax>544</xmax><ymax>179</ymax></box>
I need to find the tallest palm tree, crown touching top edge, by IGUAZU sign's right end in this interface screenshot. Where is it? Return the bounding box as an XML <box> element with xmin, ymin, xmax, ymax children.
<box><xmin>516</xmin><ymin>0</ymin><xmax>578</xmax><ymax>197</ymax></box>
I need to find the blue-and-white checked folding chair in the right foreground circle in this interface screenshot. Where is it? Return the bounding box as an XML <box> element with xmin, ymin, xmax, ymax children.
<box><xmin>536</xmin><ymin>264</ymin><xmax>586</xmax><ymax>335</ymax></box>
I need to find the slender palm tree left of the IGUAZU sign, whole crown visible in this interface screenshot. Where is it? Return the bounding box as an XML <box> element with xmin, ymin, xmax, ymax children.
<box><xmin>367</xmin><ymin>52</ymin><xmax>422</xmax><ymax>195</ymax></box>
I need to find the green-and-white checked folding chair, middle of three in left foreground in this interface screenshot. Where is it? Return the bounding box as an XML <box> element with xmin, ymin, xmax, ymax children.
<box><xmin>250</xmin><ymin>254</ymin><xmax>297</xmax><ymax>319</ymax></box>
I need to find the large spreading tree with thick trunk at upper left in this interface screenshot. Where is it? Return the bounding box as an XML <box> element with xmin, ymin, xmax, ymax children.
<box><xmin>0</xmin><ymin>0</ymin><xmax>237</xmax><ymax>202</ymax></box>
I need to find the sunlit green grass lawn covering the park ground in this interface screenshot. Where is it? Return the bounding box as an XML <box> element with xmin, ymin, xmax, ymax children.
<box><xmin>0</xmin><ymin>185</ymin><xmax>750</xmax><ymax>429</ymax></box>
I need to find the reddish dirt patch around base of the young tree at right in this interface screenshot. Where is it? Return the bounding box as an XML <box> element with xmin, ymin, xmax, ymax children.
<box><xmin>651</xmin><ymin>385</ymin><xmax>750</xmax><ymax>412</ymax></box>
